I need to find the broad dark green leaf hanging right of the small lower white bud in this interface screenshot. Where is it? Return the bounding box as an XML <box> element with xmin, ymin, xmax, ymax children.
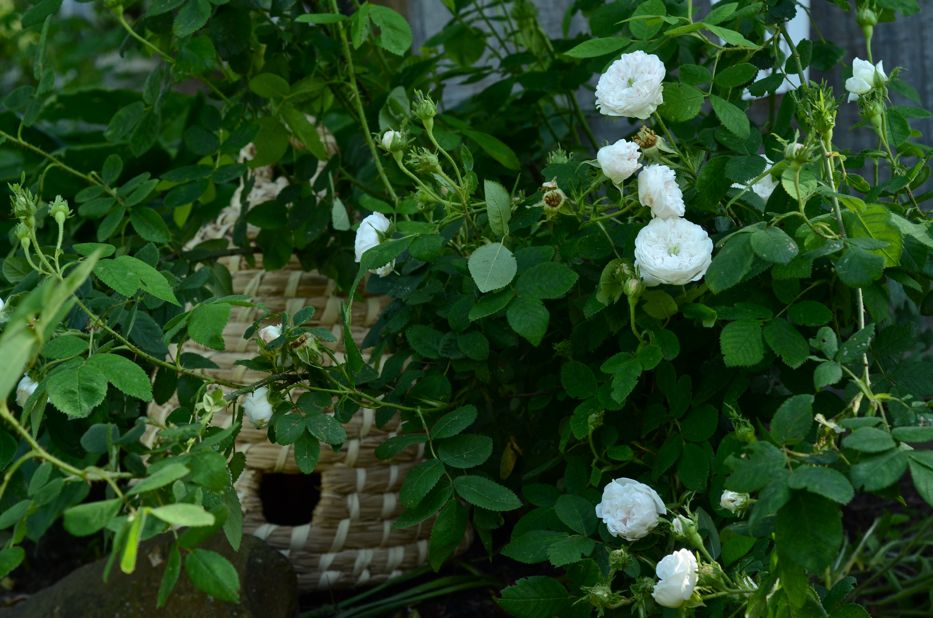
<box><xmin>775</xmin><ymin>492</ymin><xmax>842</xmax><ymax>572</ymax></box>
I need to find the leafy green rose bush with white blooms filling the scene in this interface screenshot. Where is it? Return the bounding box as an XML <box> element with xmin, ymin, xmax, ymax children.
<box><xmin>0</xmin><ymin>0</ymin><xmax>933</xmax><ymax>617</ymax></box>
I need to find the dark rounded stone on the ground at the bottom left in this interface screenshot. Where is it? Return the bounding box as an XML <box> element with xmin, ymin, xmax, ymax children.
<box><xmin>0</xmin><ymin>536</ymin><xmax>298</xmax><ymax>618</ymax></box>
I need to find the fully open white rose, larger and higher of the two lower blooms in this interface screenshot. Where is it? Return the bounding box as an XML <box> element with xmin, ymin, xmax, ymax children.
<box><xmin>596</xmin><ymin>478</ymin><xmax>667</xmax><ymax>541</ymax></box>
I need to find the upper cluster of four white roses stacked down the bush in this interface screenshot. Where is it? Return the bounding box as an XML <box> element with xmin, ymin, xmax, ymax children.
<box><xmin>596</xmin><ymin>51</ymin><xmax>712</xmax><ymax>286</ymax></box>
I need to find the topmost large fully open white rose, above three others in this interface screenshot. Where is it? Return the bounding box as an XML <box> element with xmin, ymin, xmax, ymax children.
<box><xmin>596</xmin><ymin>50</ymin><xmax>667</xmax><ymax>120</ymax></box>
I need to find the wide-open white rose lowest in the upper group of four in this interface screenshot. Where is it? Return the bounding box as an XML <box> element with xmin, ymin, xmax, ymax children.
<box><xmin>635</xmin><ymin>219</ymin><xmax>713</xmax><ymax>286</ymax></box>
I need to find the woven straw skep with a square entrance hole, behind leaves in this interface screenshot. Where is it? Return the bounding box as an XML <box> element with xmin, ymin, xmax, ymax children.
<box><xmin>149</xmin><ymin>156</ymin><xmax>468</xmax><ymax>591</ymax></box>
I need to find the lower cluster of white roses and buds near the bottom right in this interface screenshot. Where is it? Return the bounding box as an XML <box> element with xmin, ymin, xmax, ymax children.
<box><xmin>596</xmin><ymin>478</ymin><xmax>751</xmax><ymax>608</ymax></box>
